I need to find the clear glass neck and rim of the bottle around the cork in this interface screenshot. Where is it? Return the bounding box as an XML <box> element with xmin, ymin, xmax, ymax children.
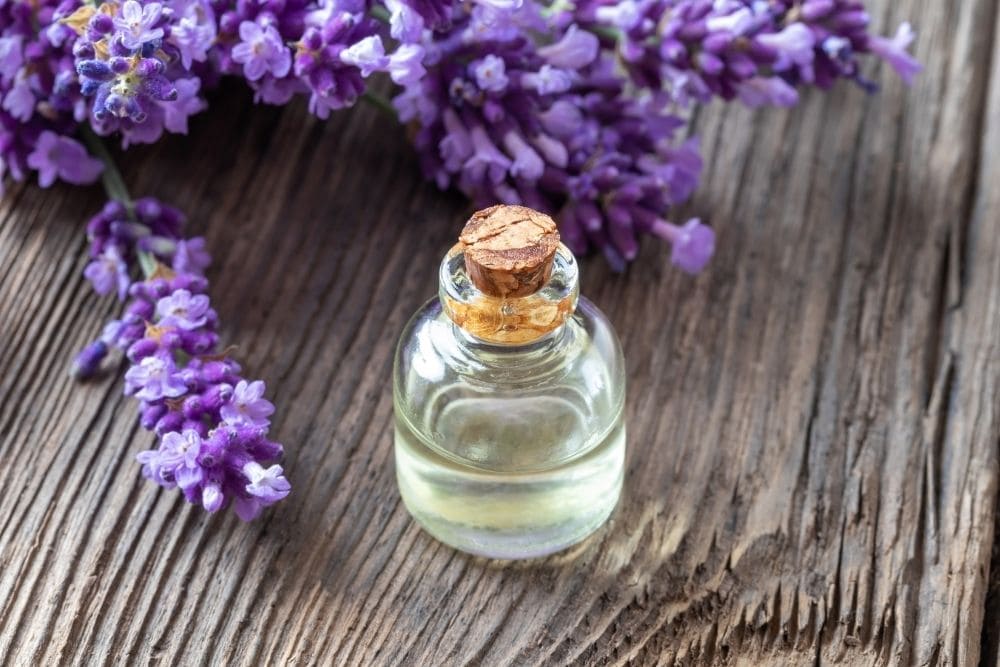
<box><xmin>438</xmin><ymin>244</ymin><xmax>580</xmax><ymax>345</ymax></box>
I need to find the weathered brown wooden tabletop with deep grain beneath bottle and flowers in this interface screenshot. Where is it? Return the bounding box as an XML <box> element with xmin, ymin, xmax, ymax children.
<box><xmin>0</xmin><ymin>0</ymin><xmax>1000</xmax><ymax>665</ymax></box>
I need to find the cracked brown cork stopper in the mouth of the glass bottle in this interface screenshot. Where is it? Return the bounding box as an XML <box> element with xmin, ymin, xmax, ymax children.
<box><xmin>458</xmin><ymin>205</ymin><xmax>559</xmax><ymax>298</ymax></box>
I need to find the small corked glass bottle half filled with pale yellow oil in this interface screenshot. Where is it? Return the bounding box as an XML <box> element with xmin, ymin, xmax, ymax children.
<box><xmin>393</xmin><ymin>206</ymin><xmax>625</xmax><ymax>559</ymax></box>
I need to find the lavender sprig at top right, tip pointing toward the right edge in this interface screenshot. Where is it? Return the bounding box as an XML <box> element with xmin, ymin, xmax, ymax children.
<box><xmin>576</xmin><ymin>0</ymin><xmax>920</xmax><ymax>106</ymax></box>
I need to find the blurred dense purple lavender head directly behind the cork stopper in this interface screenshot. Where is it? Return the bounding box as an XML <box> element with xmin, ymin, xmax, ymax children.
<box><xmin>395</xmin><ymin>7</ymin><xmax>715</xmax><ymax>273</ymax></box>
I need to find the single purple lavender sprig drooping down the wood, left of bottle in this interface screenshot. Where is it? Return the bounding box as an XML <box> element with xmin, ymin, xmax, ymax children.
<box><xmin>70</xmin><ymin>140</ymin><xmax>291</xmax><ymax>521</ymax></box>
